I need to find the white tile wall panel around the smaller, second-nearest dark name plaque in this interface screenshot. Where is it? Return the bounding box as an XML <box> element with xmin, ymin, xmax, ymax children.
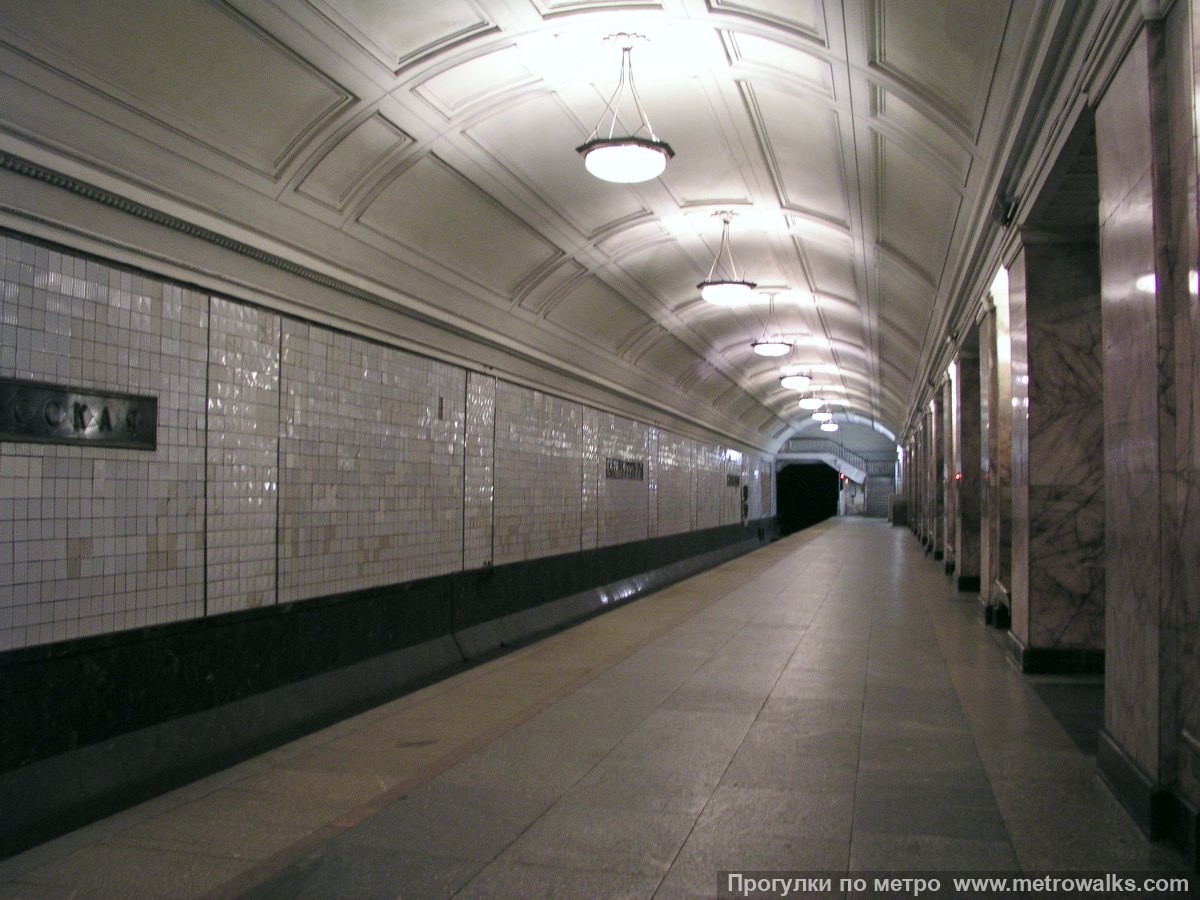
<box><xmin>592</xmin><ymin>413</ymin><xmax>650</xmax><ymax>547</ymax></box>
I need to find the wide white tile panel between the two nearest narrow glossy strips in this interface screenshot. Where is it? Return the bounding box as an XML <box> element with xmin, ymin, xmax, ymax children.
<box><xmin>278</xmin><ymin>320</ymin><xmax>466</xmax><ymax>601</ymax></box>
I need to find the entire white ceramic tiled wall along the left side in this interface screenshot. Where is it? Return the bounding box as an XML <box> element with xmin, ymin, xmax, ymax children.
<box><xmin>0</xmin><ymin>238</ymin><xmax>770</xmax><ymax>649</ymax></box>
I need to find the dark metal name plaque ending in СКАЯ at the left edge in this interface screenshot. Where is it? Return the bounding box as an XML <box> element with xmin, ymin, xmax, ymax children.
<box><xmin>0</xmin><ymin>378</ymin><xmax>158</xmax><ymax>450</ymax></box>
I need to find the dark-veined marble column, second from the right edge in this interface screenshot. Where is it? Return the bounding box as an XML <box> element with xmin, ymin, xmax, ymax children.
<box><xmin>1009</xmin><ymin>240</ymin><xmax>1104</xmax><ymax>672</ymax></box>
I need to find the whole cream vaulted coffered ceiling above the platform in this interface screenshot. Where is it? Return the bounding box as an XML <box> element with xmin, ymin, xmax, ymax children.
<box><xmin>0</xmin><ymin>0</ymin><xmax>1094</xmax><ymax>449</ymax></box>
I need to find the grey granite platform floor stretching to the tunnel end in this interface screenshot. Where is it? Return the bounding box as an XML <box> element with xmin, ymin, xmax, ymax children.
<box><xmin>0</xmin><ymin>518</ymin><xmax>1182</xmax><ymax>900</ymax></box>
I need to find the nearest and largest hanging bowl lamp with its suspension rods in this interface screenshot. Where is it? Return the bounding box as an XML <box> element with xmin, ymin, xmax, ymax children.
<box><xmin>575</xmin><ymin>32</ymin><xmax>674</xmax><ymax>184</ymax></box>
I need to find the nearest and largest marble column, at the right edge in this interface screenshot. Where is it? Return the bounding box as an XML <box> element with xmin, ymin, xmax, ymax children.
<box><xmin>1096</xmin><ymin>8</ymin><xmax>1200</xmax><ymax>863</ymax></box>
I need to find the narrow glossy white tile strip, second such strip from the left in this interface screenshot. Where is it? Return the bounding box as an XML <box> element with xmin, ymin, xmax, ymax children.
<box><xmin>463</xmin><ymin>372</ymin><xmax>496</xmax><ymax>569</ymax></box>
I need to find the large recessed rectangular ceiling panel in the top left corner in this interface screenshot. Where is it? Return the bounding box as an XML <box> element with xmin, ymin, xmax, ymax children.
<box><xmin>2</xmin><ymin>0</ymin><xmax>352</xmax><ymax>175</ymax></box>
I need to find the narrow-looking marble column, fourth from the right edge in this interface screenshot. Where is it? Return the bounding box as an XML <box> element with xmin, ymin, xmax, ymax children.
<box><xmin>953</xmin><ymin>338</ymin><xmax>983</xmax><ymax>590</ymax></box>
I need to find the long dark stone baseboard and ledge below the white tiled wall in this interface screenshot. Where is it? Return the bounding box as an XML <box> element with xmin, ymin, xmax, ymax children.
<box><xmin>0</xmin><ymin>518</ymin><xmax>778</xmax><ymax>858</ymax></box>
